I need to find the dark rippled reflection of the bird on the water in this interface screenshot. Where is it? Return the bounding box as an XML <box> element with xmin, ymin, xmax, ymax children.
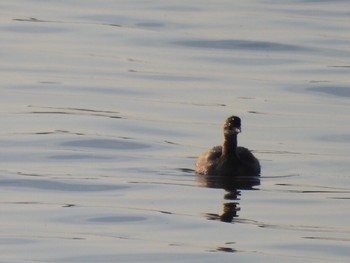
<box><xmin>197</xmin><ymin>175</ymin><xmax>260</xmax><ymax>223</ymax></box>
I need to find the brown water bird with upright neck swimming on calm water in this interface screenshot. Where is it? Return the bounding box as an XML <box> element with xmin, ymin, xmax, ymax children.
<box><xmin>196</xmin><ymin>116</ymin><xmax>260</xmax><ymax>177</ymax></box>
